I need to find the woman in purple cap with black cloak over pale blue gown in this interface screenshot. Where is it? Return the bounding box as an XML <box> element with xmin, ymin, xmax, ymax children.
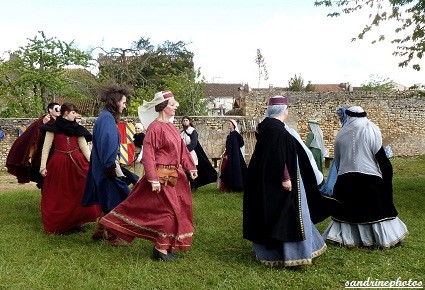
<box><xmin>243</xmin><ymin>96</ymin><xmax>337</xmax><ymax>266</ymax></box>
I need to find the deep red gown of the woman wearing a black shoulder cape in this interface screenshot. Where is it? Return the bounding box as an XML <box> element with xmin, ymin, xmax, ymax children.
<box><xmin>41</xmin><ymin>133</ymin><xmax>101</xmax><ymax>234</ymax></box>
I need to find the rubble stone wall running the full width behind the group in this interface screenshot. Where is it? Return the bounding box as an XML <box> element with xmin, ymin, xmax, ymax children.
<box><xmin>0</xmin><ymin>89</ymin><xmax>425</xmax><ymax>169</ymax></box>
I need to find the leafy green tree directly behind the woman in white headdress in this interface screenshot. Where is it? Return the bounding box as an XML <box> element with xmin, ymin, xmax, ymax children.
<box><xmin>95</xmin><ymin>37</ymin><xmax>206</xmax><ymax>115</ymax></box>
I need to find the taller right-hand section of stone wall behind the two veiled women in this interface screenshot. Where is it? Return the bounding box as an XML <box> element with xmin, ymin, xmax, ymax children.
<box><xmin>245</xmin><ymin>89</ymin><xmax>425</xmax><ymax>156</ymax></box>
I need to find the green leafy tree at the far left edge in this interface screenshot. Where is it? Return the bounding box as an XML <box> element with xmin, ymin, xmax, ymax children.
<box><xmin>0</xmin><ymin>31</ymin><xmax>91</xmax><ymax>117</ymax></box>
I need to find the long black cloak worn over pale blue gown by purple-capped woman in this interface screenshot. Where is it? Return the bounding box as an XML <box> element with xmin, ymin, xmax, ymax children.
<box><xmin>243</xmin><ymin>118</ymin><xmax>337</xmax><ymax>245</ymax></box>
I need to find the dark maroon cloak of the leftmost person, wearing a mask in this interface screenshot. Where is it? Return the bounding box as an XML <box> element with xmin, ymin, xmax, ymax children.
<box><xmin>6</xmin><ymin>116</ymin><xmax>55</xmax><ymax>188</ymax></box>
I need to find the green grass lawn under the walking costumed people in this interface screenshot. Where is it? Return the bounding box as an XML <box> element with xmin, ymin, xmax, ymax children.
<box><xmin>0</xmin><ymin>156</ymin><xmax>425</xmax><ymax>289</ymax></box>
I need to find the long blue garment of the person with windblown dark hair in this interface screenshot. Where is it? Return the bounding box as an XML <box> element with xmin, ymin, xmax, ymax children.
<box><xmin>83</xmin><ymin>109</ymin><xmax>130</xmax><ymax>213</ymax></box>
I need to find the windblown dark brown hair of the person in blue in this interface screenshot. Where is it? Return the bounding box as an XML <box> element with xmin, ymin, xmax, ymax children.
<box><xmin>99</xmin><ymin>84</ymin><xmax>130</xmax><ymax>123</ymax></box>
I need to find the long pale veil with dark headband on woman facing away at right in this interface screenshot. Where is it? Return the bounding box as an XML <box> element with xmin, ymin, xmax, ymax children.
<box><xmin>334</xmin><ymin>106</ymin><xmax>382</xmax><ymax>177</ymax></box>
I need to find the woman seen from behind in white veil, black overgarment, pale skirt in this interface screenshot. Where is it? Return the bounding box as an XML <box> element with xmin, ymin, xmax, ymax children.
<box><xmin>323</xmin><ymin>106</ymin><xmax>408</xmax><ymax>248</ymax></box>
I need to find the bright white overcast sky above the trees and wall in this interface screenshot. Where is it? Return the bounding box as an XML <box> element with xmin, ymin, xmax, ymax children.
<box><xmin>0</xmin><ymin>0</ymin><xmax>425</xmax><ymax>87</ymax></box>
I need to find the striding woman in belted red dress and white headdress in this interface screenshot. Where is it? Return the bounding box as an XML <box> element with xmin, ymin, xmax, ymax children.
<box><xmin>100</xmin><ymin>91</ymin><xmax>198</xmax><ymax>261</ymax></box>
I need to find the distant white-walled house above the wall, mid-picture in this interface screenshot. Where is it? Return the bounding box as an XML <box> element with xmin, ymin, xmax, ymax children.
<box><xmin>204</xmin><ymin>83</ymin><xmax>249</xmax><ymax>115</ymax></box>
